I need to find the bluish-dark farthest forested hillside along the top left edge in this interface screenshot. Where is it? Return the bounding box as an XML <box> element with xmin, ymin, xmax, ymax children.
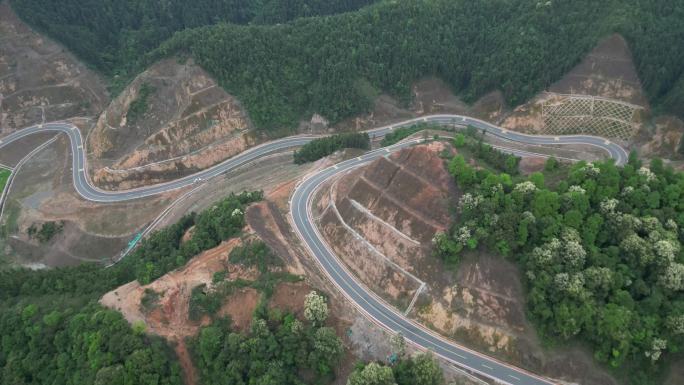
<box><xmin>11</xmin><ymin>0</ymin><xmax>373</xmax><ymax>77</ymax></box>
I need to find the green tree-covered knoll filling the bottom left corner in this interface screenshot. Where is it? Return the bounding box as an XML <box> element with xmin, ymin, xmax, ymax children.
<box><xmin>0</xmin><ymin>301</ymin><xmax>182</xmax><ymax>385</ymax></box>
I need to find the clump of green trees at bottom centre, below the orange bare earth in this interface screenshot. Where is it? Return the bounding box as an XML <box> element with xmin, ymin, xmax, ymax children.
<box><xmin>191</xmin><ymin>292</ymin><xmax>343</xmax><ymax>385</ymax></box>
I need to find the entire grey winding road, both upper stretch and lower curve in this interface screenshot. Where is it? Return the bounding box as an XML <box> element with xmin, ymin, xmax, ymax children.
<box><xmin>0</xmin><ymin>115</ymin><xmax>628</xmax><ymax>385</ymax></box>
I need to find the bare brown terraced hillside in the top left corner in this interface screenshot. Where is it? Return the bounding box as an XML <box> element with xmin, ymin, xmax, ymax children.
<box><xmin>0</xmin><ymin>1</ymin><xmax>108</xmax><ymax>135</ymax></box>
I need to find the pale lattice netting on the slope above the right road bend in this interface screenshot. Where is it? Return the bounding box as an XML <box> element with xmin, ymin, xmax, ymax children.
<box><xmin>542</xmin><ymin>95</ymin><xmax>643</xmax><ymax>140</ymax></box>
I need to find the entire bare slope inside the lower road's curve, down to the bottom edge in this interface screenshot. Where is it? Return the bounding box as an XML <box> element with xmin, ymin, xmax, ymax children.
<box><xmin>313</xmin><ymin>142</ymin><xmax>613</xmax><ymax>385</ymax></box>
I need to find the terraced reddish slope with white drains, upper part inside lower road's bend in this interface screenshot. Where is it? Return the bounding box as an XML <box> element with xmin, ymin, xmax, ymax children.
<box><xmin>315</xmin><ymin>143</ymin><xmax>456</xmax><ymax>311</ymax></box>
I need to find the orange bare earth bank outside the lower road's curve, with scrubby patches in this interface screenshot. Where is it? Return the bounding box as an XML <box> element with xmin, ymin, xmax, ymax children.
<box><xmin>101</xmin><ymin>160</ymin><xmax>486</xmax><ymax>385</ymax></box>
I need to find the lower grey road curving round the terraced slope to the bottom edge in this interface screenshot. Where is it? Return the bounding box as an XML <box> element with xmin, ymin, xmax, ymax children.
<box><xmin>290</xmin><ymin>141</ymin><xmax>554</xmax><ymax>385</ymax></box>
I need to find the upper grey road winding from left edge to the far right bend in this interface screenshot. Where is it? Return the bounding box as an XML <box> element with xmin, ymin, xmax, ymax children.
<box><xmin>0</xmin><ymin>115</ymin><xmax>627</xmax><ymax>202</ymax></box>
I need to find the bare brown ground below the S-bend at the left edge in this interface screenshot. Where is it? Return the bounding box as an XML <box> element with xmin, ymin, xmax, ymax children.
<box><xmin>2</xmin><ymin>136</ymin><xmax>178</xmax><ymax>266</ymax></box>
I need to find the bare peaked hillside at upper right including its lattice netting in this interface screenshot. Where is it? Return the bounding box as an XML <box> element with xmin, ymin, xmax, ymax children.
<box><xmin>500</xmin><ymin>35</ymin><xmax>684</xmax><ymax>159</ymax></box>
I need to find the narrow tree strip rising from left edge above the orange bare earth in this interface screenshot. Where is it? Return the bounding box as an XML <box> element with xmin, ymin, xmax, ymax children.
<box><xmin>0</xmin><ymin>192</ymin><xmax>262</xmax><ymax>301</ymax></box>
